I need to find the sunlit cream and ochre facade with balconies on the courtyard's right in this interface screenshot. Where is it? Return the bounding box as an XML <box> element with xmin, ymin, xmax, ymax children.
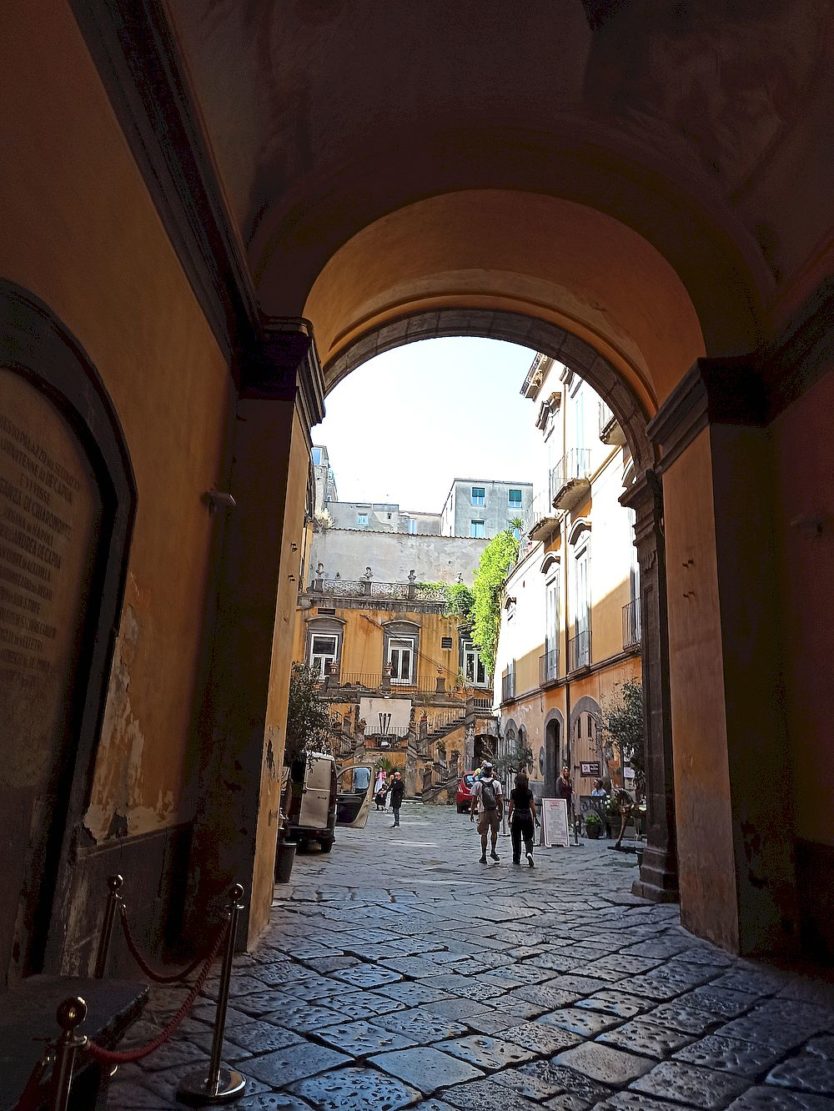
<box><xmin>495</xmin><ymin>354</ymin><xmax>642</xmax><ymax>812</ymax></box>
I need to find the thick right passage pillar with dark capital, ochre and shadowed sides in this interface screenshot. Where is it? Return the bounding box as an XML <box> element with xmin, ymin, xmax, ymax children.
<box><xmin>649</xmin><ymin>360</ymin><xmax>797</xmax><ymax>953</ymax></box>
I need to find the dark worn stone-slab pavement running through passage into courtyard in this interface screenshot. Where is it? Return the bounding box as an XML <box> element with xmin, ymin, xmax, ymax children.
<box><xmin>108</xmin><ymin>803</ymin><xmax>834</xmax><ymax>1111</ymax></box>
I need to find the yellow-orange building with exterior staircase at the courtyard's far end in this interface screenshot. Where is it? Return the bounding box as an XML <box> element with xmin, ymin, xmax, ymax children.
<box><xmin>293</xmin><ymin>551</ymin><xmax>494</xmax><ymax>802</ymax></box>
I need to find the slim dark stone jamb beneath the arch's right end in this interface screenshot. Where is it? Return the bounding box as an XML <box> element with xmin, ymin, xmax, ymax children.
<box><xmin>620</xmin><ymin>471</ymin><xmax>677</xmax><ymax>902</ymax></box>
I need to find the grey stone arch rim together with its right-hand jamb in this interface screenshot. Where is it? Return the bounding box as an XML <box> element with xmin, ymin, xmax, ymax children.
<box><xmin>324</xmin><ymin>308</ymin><xmax>677</xmax><ymax>901</ymax></box>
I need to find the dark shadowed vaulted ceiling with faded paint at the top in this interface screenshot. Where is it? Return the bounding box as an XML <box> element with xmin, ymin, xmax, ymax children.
<box><xmin>170</xmin><ymin>0</ymin><xmax>834</xmax><ymax>373</ymax></box>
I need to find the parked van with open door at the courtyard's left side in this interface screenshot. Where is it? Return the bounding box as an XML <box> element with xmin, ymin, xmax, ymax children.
<box><xmin>283</xmin><ymin>752</ymin><xmax>373</xmax><ymax>852</ymax></box>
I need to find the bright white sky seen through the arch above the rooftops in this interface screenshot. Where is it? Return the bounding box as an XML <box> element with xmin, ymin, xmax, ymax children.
<box><xmin>313</xmin><ymin>338</ymin><xmax>535</xmax><ymax>513</ymax></box>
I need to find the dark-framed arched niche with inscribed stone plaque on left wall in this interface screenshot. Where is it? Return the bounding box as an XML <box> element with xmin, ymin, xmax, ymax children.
<box><xmin>0</xmin><ymin>282</ymin><xmax>135</xmax><ymax>982</ymax></box>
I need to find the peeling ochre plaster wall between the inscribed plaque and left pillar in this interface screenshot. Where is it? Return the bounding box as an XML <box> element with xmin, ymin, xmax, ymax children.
<box><xmin>0</xmin><ymin>0</ymin><xmax>231</xmax><ymax>841</ymax></box>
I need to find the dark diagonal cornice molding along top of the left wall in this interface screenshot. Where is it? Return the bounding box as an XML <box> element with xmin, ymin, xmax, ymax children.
<box><xmin>70</xmin><ymin>0</ymin><xmax>259</xmax><ymax>379</ymax></box>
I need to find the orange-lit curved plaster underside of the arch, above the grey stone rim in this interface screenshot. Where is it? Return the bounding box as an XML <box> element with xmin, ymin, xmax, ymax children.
<box><xmin>304</xmin><ymin>190</ymin><xmax>704</xmax><ymax>413</ymax></box>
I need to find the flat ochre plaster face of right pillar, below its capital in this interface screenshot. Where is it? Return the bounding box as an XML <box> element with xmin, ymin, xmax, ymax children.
<box><xmin>663</xmin><ymin>431</ymin><xmax>738</xmax><ymax>949</ymax></box>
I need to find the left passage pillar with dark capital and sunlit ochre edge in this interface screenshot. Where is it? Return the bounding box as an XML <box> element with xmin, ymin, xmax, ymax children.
<box><xmin>191</xmin><ymin>319</ymin><xmax>321</xmax><ymax>948</ymax></box>
